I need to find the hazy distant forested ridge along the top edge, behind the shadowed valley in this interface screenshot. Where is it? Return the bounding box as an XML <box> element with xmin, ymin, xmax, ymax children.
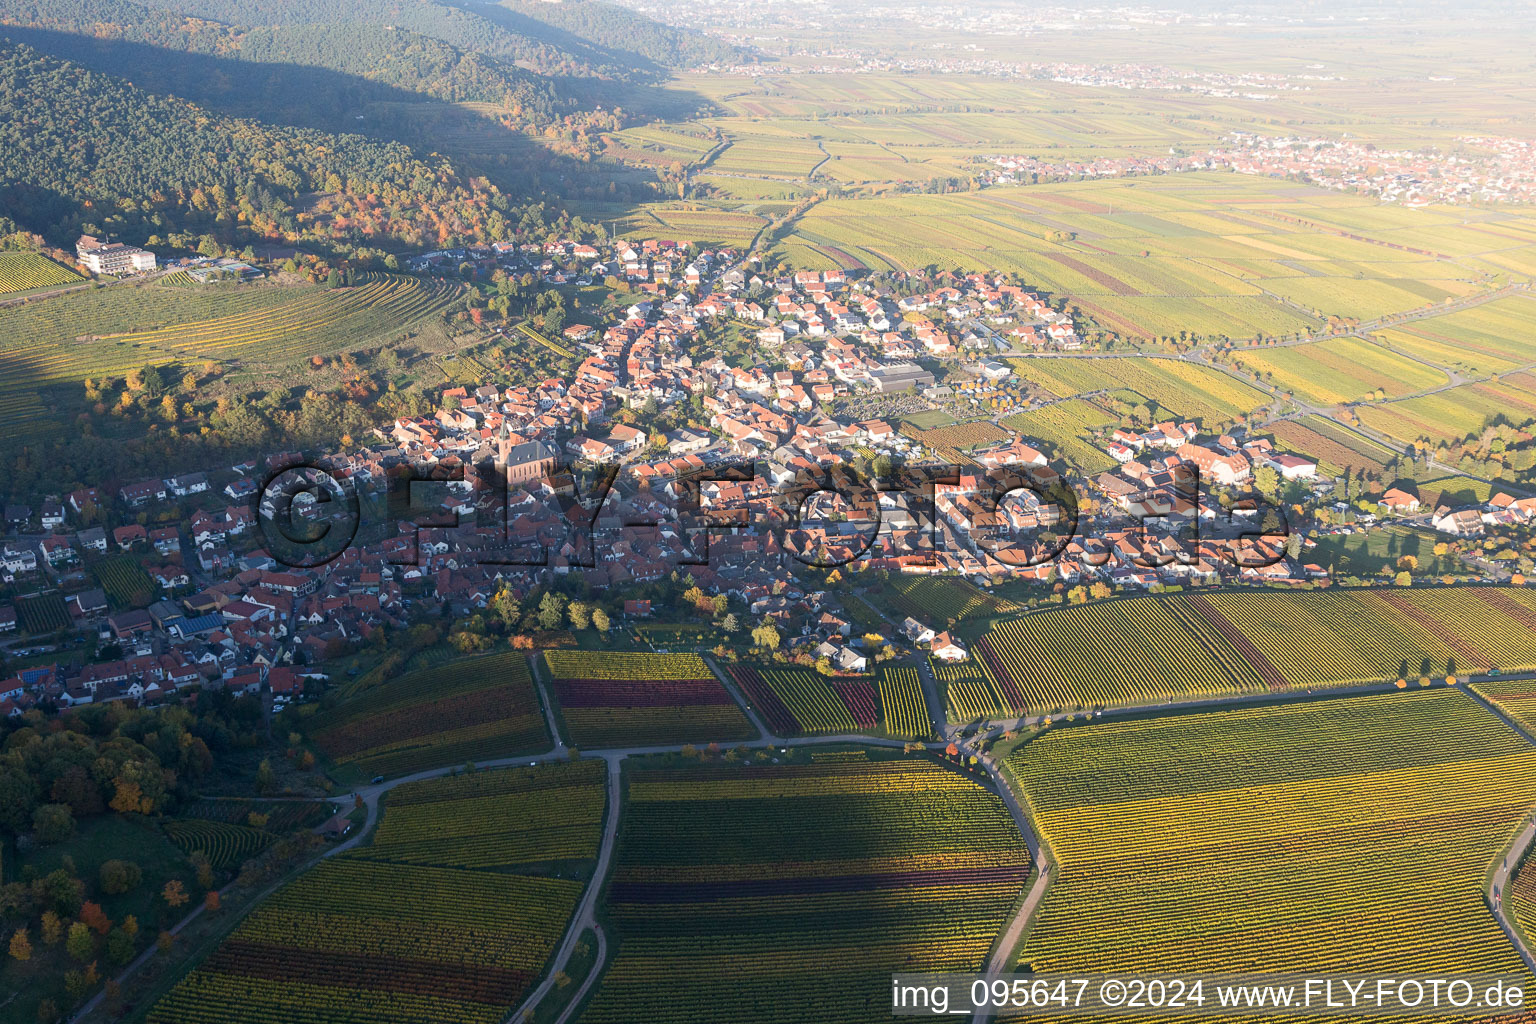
<box><xmin>100</xmin><ymin>0</ymin><xmax>750</xmax><ymax>80</ymax></box>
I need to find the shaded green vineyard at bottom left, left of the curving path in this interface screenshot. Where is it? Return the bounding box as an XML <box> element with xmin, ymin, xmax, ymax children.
<box><xmin>147</xmin><ymin>761</ymin><xmax>605</xmax><ymax>1024</ymax></box>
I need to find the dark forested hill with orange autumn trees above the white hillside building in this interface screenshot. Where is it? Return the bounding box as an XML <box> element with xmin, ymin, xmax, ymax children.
<box><xmin>0</xmin><ymin>41</ymin><xmax>534</xmax><ymax>249</ymax></box>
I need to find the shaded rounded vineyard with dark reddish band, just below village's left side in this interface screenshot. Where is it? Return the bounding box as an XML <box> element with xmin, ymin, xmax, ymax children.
<box><xmin>303</xmin><ymin>651</ymin><xmax>551</xmax><ymax>775</ymax></box>
